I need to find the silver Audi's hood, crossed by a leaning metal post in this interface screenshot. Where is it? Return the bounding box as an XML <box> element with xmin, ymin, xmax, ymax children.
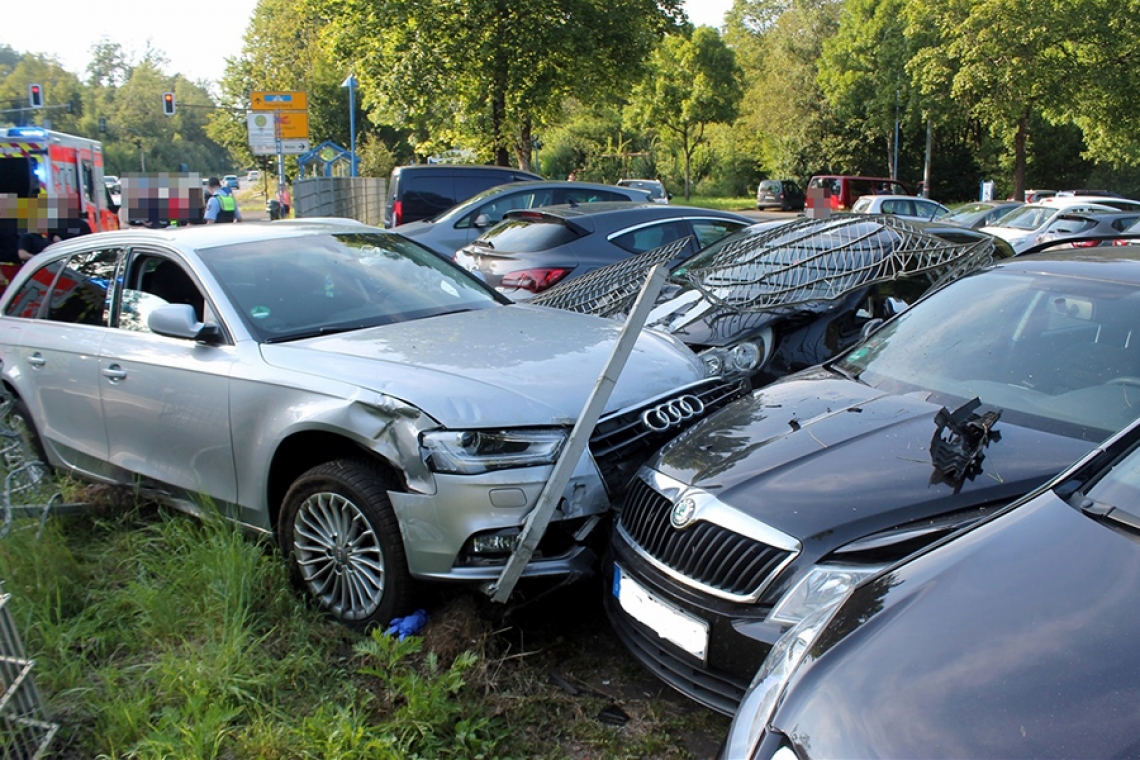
<box><xmin>261</xmin><ymin>305</ymin><xmax>705</xmax><ymax>427</ymax></box>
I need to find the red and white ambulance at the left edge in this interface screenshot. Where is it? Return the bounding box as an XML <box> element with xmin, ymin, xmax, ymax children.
<box><xmin>0</xmin><ymin>126</ymin><xmax>119</xmax><ymax>279</ymax></box>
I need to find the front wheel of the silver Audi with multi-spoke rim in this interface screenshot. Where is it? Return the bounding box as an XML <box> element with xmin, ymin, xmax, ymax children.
<box><xmin>279</xmin><ymin>459</ymin><xmax>413</xmax><ymax>630</ymax></box>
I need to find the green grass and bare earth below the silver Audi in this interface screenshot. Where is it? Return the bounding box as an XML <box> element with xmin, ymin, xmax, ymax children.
<box><xmin>0</xmin><ymin>499</ymin><xmax>727</xmax><ymax>760</ymax></box>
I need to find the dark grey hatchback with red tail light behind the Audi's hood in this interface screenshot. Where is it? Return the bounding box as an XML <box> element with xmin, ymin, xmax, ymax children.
<box><xmin>455</xmin><ymin>202</ymin><xmax>754</xmax><ymax>301</ymax></box>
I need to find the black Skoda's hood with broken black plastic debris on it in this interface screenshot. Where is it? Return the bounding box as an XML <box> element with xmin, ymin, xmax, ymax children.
<box><xmin>651</xmin><ymin>369</ymin><xmax>1093</xmax><ymax>542</ymax></box>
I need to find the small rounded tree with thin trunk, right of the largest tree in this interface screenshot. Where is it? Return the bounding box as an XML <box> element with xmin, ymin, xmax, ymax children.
<box><xmin>627</xmin><ymin>26</ymin><xmax>743</xmax><ymax>201</ymax></box>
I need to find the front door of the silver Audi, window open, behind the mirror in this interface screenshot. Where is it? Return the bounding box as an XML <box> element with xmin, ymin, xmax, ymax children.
<box><xmin>99</xmin><ymin>250</ymin><xmax>239</xmax><ymax>518</ymax></box>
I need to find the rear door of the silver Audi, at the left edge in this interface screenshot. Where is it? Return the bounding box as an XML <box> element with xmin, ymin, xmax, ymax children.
<box><xmin>3</xmin><ymin>247</ymin><xmax>124</xmax><ymax>479</ymax></box>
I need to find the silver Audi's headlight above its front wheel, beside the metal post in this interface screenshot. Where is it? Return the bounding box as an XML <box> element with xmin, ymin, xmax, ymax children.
<box><xmin>422</xmin><ymin>430</ymin><xmax>567</xmax><ymax>475</ymax></box>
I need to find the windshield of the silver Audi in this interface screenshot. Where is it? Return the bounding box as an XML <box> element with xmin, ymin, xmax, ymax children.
<box><xmin>198</xmin><ymin>232</ymin><xmax>503</xmax><ymax>342</ymax></box>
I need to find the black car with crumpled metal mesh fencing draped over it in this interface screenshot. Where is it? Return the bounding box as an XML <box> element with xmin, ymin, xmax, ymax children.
<box><xmin>531</xmin><ymin>214</ymin><xmax>1013</xmax><ymax>385</ymax></box>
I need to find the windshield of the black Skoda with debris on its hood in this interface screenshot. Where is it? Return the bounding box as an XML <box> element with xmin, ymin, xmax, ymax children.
<box><xmin>832</xmin><ymin>270</ymin><xmax>1140</xmax><ymax>441</ymax></box>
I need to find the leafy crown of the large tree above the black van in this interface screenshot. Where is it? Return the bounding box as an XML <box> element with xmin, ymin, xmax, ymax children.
<box><xmin>323</xmin><ymin>0</ymin><xmax>683</xmax><ymax>169</ymax></box>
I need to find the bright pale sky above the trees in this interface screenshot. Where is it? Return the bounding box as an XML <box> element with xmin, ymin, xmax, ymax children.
<box><xmin>0</xmin><ymin>0</ymin><xmax>732</xmax><ymax>82</ymax></box>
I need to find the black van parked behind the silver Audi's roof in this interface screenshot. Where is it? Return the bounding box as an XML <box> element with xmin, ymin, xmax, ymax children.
<box><xmin>384</xmin><ymin>164</ymin><xmax>543</xmax><ymax>227</ymax></box>
